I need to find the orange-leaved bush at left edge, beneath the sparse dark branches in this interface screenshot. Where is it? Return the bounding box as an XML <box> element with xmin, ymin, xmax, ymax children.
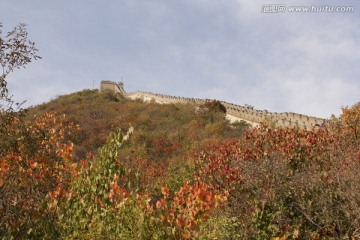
<box><xmin>0</xmin><ymin>113</ymin><xmax>76</xmax><ymax>235</ymax></box>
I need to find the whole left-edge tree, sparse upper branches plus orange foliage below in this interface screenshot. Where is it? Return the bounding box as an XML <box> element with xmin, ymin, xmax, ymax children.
<box><xmin>0</xmin><ymin>23</ymin><xmax>62</xmax><ymax>239</ymax></box>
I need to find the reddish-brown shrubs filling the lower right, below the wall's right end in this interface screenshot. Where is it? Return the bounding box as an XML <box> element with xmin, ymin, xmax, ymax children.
<box><xmin>198</xmin><ymin>126</ymin><xmax>360</xmax><ymax>239</ymax></box>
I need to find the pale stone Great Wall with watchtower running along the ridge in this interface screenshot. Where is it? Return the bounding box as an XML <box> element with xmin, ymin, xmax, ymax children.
<box><xmin>100</xmin><ymin>81</ymin><xmax>326</xmax><ymax>129</ymax></box>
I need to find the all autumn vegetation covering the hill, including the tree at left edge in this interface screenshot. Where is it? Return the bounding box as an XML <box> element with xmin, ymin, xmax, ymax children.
<box><xmin>0</xmin><ymin>24</ymin><xmax>360</xmax><ymax>240</ymax></box>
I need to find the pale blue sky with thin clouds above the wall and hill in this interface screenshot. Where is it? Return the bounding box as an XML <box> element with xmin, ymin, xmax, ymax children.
<box><xmin>0</xmin><ymin>0</ymin><xmax>360</xmax><ymax>118</ymax></box>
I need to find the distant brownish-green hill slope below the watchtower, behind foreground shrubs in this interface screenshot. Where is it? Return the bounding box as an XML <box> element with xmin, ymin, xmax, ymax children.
<box><xmin>29</xmin><ymin>90</ymin><xmax>249</xmax><ymax>190</ymax></box>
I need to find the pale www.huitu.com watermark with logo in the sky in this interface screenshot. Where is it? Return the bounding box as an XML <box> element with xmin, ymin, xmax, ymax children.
<box><xmin>261</xmin><ymin>4</ymin><xmax>355</xmax><ymax>13</ymax></box>
